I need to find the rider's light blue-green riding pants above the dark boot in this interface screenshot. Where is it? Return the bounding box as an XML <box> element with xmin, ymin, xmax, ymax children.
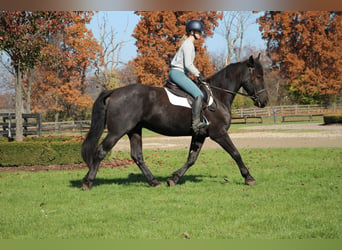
<box><xmin>169</xmin><ymin>69</ymin><xmax>203</xmax><ymax>99</ymax></box>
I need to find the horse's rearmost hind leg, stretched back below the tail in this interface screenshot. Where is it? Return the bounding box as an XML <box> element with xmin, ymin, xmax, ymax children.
<box><xmin>83</xmin><ymin>133</ymin><xmax>120</xmax><ymax>190</ymax></box>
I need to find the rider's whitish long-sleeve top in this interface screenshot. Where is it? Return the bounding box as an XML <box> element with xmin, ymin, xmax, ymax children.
<box><xmin>171</xmin><ymin>38</ymin><xmax>200</xmax><ymax>77</ymax></box>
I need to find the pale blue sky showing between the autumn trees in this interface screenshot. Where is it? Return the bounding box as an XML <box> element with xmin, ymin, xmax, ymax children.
<box><xmin>87</xmin><ymin>11</ymin><xmax>265</xmax><ymax>66</ymax></box>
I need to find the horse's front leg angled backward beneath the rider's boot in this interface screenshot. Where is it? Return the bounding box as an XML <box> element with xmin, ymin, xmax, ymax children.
<box><xmin>167</xmin><ymin>135</ymin><xmax>206</xmax><ymax>186</ymax></box>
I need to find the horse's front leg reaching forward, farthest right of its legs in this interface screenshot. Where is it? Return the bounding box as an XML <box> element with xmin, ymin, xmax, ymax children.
<box><xmin>211</xmin><ymin>133</ymin><xmax>256</xmax><ymax>186</ymax></box>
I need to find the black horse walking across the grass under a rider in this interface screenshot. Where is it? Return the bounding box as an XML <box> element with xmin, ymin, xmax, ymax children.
<box><xmin>82</xmin><ymin>56</ymin><xmax>268</xmax><ymax>189</ymax></box>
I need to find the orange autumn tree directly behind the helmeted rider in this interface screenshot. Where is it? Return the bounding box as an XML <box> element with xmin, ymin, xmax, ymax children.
<box><xmin>133</xmin><ymin>11</ymin><xmax>222</xmax><ymax>86</ymax></box>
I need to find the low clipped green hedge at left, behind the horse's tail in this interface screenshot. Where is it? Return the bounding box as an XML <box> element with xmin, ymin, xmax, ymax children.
<box><xmin>0</xmin><ymin>140</ymin><xmax>82</xmax><ymax>167</ymax></box>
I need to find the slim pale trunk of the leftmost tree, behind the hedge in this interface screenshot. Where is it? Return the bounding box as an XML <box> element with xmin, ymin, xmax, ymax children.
<box><xmin>15</xmin><ymin>66</ymin><xmax>23</xmax><ymax>142</ymax></box>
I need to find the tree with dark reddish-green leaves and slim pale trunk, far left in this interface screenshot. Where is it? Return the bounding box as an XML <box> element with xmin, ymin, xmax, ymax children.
<box><xmin>0</xmin><ymin>11</ymin><xmax>78</xmax><ymax>141</ymax></box>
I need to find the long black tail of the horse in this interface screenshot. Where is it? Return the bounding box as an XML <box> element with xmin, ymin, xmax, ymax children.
<box><xmin>82</xmin><ymin>90</ymin><xmax>113</xmax><ymax>167</ymax></box>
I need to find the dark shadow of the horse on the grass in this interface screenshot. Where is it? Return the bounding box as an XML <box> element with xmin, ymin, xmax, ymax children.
<box><xmin>70</xmin><ymin>174</ymin><xmax>204</xmax><ymax>188</ymax></box>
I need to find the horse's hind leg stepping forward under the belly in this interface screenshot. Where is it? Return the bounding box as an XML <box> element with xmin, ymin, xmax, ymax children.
<box><xmin>128</xmin><ymin>128</ymin><xmax>160</xmax><ymax>187</ymax></box>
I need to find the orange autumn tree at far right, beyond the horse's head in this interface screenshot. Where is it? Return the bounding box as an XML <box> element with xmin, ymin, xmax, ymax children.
<box><xmin>259</xmin><ymin>11</ymin><xmax>342</xmax><ymax>103</ymax></box>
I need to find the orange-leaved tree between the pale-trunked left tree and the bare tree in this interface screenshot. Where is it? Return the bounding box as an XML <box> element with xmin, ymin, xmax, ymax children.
<box><xmin>32</xmin><ymin>13</ymin><xmax>103</xmax><ymax>121</ymax></box>
